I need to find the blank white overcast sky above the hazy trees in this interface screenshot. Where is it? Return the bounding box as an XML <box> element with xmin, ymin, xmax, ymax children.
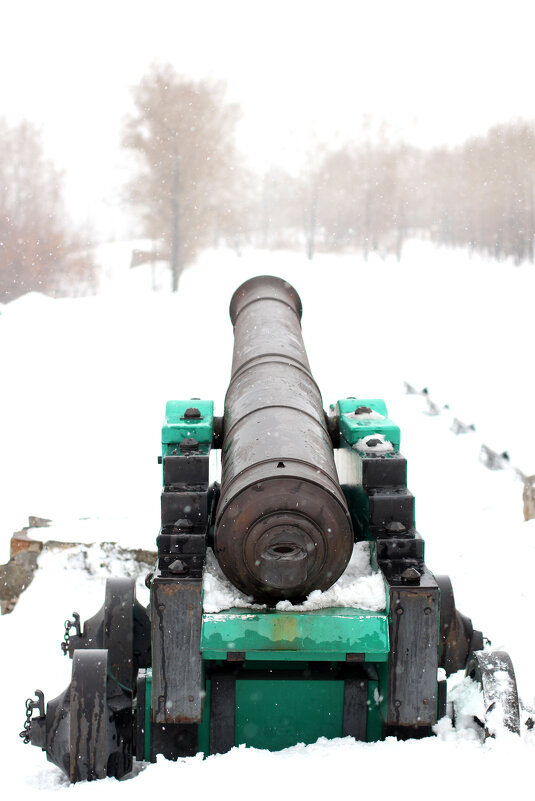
<box><xmin>4</xmin><ymin>0</ymin><xmax>535</xmax><ymax>235</ymax></box>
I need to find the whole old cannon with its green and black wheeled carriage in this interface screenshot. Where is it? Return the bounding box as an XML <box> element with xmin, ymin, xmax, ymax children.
<box><xmin>21</xmin><ymin>276</ymin><xmax>520</xmax><ymax>782</ymax></box>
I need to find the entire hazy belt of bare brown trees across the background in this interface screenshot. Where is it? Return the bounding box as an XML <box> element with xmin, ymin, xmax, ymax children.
<box><xmin>0</xmin><ymin>65</ymin><xmax>535</xmax><ymax>303</ymax></box>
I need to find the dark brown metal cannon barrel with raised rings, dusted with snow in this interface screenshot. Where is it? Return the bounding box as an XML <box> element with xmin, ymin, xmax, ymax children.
<box><xmin>214</xmin><ymin>276</ymin><xmax>353</xmax><ymax>603</ymax></box>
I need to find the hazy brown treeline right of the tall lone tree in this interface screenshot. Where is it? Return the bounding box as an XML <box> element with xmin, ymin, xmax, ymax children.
<box><xmin>255</xmin><ymin>121</ymin><xmax>535</xmax><ymax>263</ymax></box>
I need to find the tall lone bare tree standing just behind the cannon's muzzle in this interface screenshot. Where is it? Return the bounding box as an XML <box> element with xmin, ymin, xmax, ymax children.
<box><xmin>123</xmin><ymin>65</ymin><xmax>240</xmax><ymax>291</ymax></box>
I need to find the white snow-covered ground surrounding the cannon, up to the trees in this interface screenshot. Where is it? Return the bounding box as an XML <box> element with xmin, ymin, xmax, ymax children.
<box><xmin>0</xmin><ymin>241</ymin><xmax>535</xmax><ymax>799</ymax></box>
